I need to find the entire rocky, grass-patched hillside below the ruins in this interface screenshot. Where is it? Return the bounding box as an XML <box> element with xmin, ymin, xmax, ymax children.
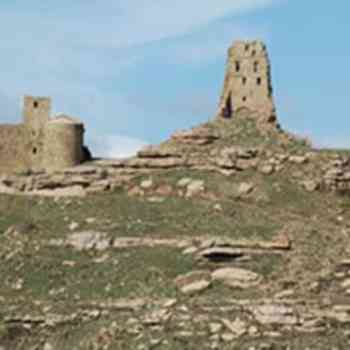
<box><xmin>0</xmin><ymin>111</ymin><xmax>350</xmax><ymax>350</ymax></box>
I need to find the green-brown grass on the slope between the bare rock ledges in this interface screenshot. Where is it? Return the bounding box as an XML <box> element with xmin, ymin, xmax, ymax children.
<box><xmin>0</xmin><ymin>115</ymin><xmax>350</xmax><ymax>349</ymax></box>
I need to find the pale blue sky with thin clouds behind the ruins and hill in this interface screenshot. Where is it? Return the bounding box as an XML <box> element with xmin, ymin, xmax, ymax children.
<box><xmin>0</xmin><ymin>0</ymin><xmax>350</xmax><ymax>157</ymax></box>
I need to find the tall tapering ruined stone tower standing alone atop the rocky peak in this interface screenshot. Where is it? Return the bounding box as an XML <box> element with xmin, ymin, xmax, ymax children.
<box><xmin>217</xmin><ymin>41</ymin><xmax>276</xmax><ymax>122</ymax></box>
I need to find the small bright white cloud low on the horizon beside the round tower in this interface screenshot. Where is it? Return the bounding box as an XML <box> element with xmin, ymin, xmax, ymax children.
<box><xmin>87</xmin><ymin>135</ymin><xmax>147</xmax><ymax>158</ymax></box>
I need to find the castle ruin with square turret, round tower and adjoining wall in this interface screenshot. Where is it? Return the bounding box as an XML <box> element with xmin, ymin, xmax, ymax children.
<box><xmin>0</xmin><ymin>96</ymin><xmax>84</xmax><ymax>171</ymax></box>
